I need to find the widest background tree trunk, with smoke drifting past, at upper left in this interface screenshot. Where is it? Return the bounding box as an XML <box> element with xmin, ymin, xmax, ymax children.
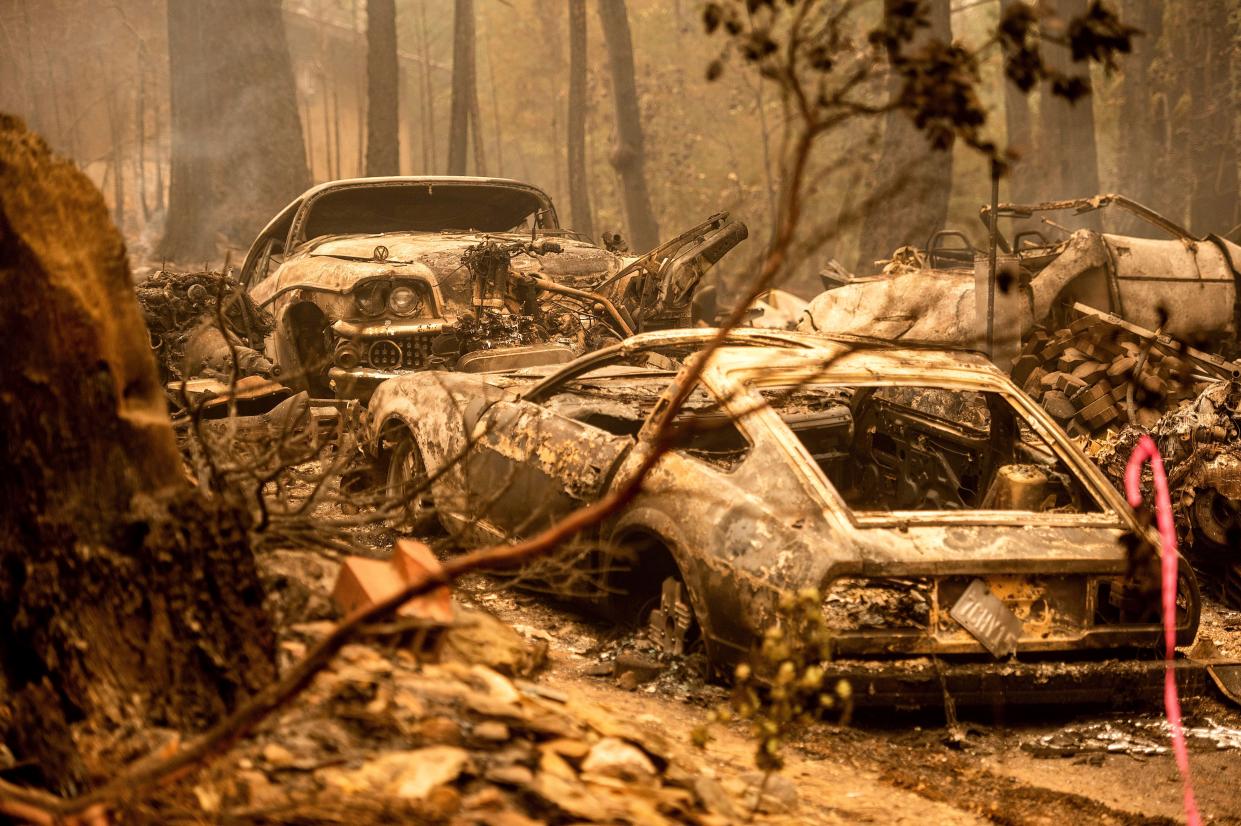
<box><xmin>161</xmin><ymin>0</ymin><xmax>310</xmax><ymax>260</ymax></box>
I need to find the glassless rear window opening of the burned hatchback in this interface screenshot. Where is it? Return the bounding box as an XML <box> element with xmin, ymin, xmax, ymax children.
<box><xmin>759</xmin><ymin>386</ymin><xmax>1102</xmax><ymax>513</ymax></box>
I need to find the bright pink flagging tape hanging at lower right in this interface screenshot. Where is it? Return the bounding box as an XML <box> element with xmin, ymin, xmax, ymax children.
<box><xmin>1124</xmin><ymin>435</ymin><xmax>1203</xmax><ymax>826</ymax></box>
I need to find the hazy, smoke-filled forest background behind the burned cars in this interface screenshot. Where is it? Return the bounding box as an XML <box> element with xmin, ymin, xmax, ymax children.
<box><xmin>0</xmin><ymin>0</ymin><xmax>1241</xmax><ymax>294</ymax></box>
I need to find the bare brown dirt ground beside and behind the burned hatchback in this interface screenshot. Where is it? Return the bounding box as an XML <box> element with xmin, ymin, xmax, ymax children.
<box><xmin>463</xmin><ymin>578</ymin><xmax>1241</xmax><ymax>824</ymax></box>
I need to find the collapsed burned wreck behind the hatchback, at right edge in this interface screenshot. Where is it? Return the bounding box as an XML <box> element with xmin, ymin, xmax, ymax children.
<box><xmin>799</xmin><ymin>195</ymin><xmax>1241</xmax><ymax>366</ymax></box>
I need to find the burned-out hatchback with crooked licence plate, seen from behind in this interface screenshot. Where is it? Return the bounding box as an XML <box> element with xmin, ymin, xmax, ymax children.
<box><xmin>369</xmin><ymin>330</ymin><xmax>1200</xmax><ymax>702</ymax></box>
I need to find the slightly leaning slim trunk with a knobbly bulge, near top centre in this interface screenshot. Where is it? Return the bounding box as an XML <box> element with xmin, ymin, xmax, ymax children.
<box><xmin>599</xmin><ymin>0</ymin><xmax>659</xmax><ymax>252</ymax></box>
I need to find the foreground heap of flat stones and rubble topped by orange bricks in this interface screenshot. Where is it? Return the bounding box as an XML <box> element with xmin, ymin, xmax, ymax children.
<box><xmin>134</xmin><ymin>542</ymin><xmax>742</xmax><ymax>826</ymax></box>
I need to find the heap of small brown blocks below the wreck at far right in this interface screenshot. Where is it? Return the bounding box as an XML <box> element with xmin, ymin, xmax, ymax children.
<box><xmin>1013</xmin><ymin>315</ymin><xmax>1225</xmax><ymax>437</ymax></box>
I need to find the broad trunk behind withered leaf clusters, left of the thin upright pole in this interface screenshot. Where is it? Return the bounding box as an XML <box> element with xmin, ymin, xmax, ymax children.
<box><xmin>859</xmin><ymin>0</ymin><xmax>952</xmax><ymax>273</ymax></box>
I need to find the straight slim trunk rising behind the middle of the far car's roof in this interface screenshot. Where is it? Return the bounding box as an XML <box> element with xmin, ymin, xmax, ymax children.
<box><xmin>366</xmin><ymin>0</ymin><xmax>401</xmax><ymax>175</ymax></box>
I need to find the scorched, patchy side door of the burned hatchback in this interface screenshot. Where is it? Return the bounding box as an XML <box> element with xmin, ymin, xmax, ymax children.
<box><xmin>463</xmin><ymin>399</ymin><xmax>634</xmax><ymax>540</ymax></box>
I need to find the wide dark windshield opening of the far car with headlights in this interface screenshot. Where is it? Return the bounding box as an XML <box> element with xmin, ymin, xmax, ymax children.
<box><xmin>302</xmin><ymin>182</ymin><xmax>550</xmax><ymax>238</ymax></box>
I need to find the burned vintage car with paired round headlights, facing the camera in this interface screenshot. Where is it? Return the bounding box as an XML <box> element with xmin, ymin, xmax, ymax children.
<box><xmin>241</xmin><ymin>177</ymin><xmax>746</xmax><ymax>399</ymax></box>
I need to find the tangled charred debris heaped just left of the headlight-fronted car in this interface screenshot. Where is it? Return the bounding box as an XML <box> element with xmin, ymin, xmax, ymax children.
<box><xmin>137</xmin><ymin>269</ymin><xmax>274</xmax><ymax>383</ymax></box>
